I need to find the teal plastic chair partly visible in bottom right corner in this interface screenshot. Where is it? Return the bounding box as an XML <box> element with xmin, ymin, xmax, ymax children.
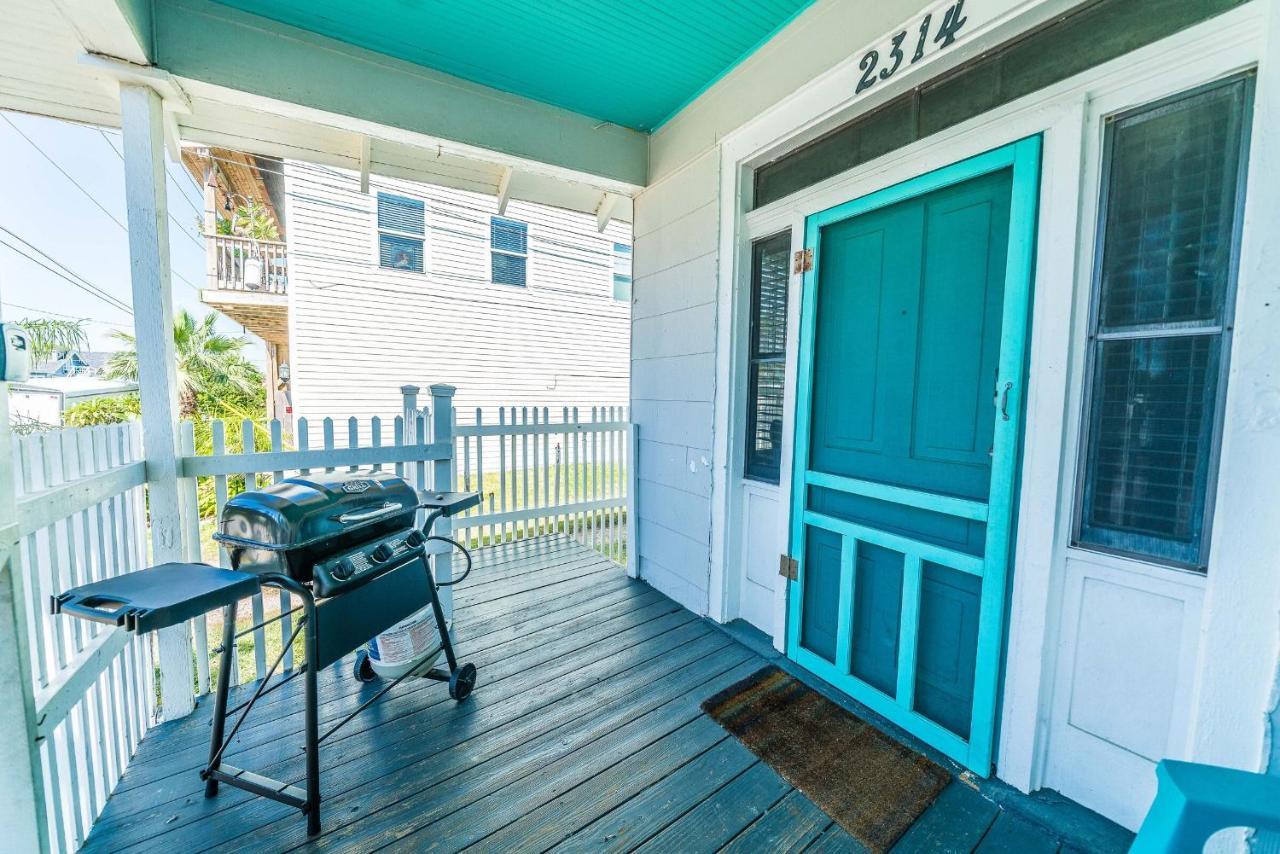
<box><xmin>1129</xmin><ymin>759</ymin><xmax>1280</xmax><ymax>854</ymax></box>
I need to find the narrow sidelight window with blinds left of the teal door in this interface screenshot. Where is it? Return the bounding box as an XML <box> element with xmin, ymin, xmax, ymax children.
<box><xmin>744</xmin><ymin>232</ymin><xmax>791</xmax><ymax>483</ymax></box>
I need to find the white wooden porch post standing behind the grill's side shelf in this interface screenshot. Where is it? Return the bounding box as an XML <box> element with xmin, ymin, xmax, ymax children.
<box><xmin>120</xmin><ymin>83</ymin><xmax>195</xmax><ymax>720</ymax></box>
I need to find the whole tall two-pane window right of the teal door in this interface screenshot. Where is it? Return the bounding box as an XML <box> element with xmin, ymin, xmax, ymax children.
<box><xmin>1076</xmin><ymin>77</ymin><xmax>1252</xmax><ymax>568</ymax></box>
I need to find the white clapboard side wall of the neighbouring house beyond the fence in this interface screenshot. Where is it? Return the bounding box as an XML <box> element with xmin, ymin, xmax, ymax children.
<box><xmin>284</xmin><ymin>161</ymin><xmax>631</xmax><ymax>442</ymax></box>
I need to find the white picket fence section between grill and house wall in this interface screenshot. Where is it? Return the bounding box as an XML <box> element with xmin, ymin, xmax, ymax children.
<box><xmin>453</xmin><ymin>406</ymin><xmax>634</xmax><ymax>563</ymax></box>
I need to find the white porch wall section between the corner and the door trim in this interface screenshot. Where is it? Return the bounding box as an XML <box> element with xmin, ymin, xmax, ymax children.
<box><xmin>631</xmin><ymin>151</ymin><xmax>719</xmax><ymax>615</ymax></box>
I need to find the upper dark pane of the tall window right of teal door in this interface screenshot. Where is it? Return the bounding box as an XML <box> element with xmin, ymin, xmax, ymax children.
<box><xmin>1100</xmin><ymin>86</ymin><xmax>1243</xmax><ymax>329</ymax></box>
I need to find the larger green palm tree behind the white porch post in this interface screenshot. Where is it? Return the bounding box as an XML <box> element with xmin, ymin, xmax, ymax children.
<box><xmin>106</xmin><ymin>309</ymin><xmax>262</xmax><ymax>419</ymax></box>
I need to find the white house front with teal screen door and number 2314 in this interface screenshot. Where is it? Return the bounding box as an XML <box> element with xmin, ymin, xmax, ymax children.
<box><xmin>631</xmin><ymin>0</ymin><xmax>1280</xmax><ymax>827</ymax></box>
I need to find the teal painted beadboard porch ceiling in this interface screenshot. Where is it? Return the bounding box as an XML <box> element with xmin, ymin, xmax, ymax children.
<box><xmin>204</xmin><ymin>0</ymin><xmax>813</xmax><ymax>131</ymax></box>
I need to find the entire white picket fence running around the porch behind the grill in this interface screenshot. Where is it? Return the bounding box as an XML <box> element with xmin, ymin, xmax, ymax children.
<box><xmin>3</xmin><ymin>387</ymin><xmax>635</xmax><ymax>851</ymax></box>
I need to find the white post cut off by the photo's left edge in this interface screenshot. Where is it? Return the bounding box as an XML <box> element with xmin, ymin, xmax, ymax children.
<box><xmin>0</xmin><ymin>307</ymin><xmax>49</xmax><ymax>851</ymax></box>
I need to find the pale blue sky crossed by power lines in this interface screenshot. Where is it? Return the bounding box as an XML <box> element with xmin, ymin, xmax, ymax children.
<box><xmin>0</xmin><ymin>111</ymin><xmax>264</xmax><ymax>365</ymax></box>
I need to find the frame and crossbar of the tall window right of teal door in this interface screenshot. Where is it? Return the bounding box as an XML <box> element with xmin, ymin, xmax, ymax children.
<box><xmin>1070</xmin><ymin>68</ymin><xmax>1257</xmax><ymax>575</ymax></box>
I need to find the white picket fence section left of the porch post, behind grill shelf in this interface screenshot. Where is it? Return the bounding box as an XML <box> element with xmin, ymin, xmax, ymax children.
<box><xmin>6</xmin><ymin>424</ymin><xmax>156</xmax><ymax>851</ymax></box>
